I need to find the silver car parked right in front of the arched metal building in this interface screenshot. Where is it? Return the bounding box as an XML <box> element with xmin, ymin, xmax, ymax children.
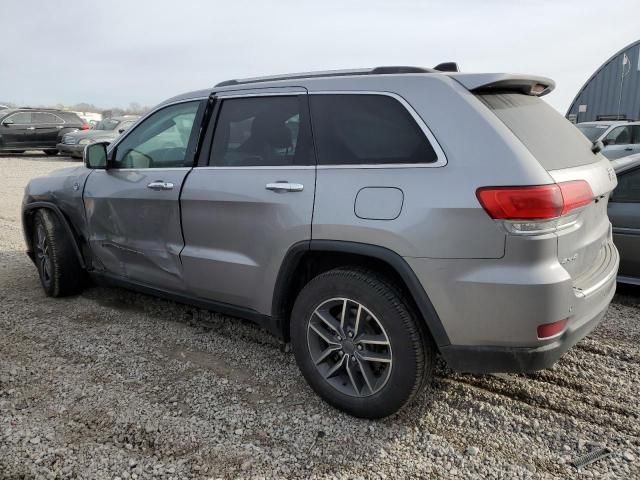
<box><xmin>576</xmin><ymin>121</ymin><xmax>640</xmax><ymax>160</ymax></box>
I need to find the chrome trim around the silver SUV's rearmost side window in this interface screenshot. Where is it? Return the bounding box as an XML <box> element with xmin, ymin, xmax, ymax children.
<box><xmin>309</xmin><ymin>90</ymin><xmax>448</xmax><ymax>170</ymax></box>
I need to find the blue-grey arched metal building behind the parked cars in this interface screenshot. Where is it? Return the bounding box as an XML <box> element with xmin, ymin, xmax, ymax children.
<box><xmin>567</xmin><ymin>40</ymin><xmax>640</xmax><ymax>123</ymax></box>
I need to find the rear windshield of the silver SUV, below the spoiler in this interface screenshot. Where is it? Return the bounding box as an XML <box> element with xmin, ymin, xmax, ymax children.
<box><xmin>478</xmin><ymin>93</ymin><xmax>598</xmax><ymax>170</ymax></box>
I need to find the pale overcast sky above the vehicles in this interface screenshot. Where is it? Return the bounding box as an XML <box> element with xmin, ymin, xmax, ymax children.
<box><xmin>0</xmin><ymin>0</ymin><xmax>640</xmax><ymax>113</ymax></box>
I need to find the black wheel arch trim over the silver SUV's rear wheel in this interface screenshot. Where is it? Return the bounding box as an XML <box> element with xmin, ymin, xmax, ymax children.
<box><xmin>271</xmin><ymin>240</ymin><xmax>450</xmax><ymax>347</ymax></box>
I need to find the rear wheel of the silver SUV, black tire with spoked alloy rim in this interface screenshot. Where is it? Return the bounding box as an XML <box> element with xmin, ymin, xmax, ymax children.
<box><xmin>291</xmin><ymin>269</ymin><xmax>434</xmax><ymax>418</ymax></box>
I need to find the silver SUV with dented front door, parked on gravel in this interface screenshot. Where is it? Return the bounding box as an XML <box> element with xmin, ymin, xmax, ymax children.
<box><xmin>23</xmin><ymin>67</ymin><xmax>618</xmax><ymax>418</ymax></box>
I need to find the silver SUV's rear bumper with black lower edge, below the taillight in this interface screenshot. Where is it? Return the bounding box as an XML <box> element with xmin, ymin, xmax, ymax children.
<box><xmin>411</xmin><ymin>241</ymin><xmax>619</xmax><ymax>373</ymax></box>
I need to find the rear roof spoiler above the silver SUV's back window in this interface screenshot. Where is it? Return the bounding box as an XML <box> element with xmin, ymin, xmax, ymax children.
<box><xmin>447</xmin><ymin>73</ymin><xmax>556</xmax><ymax>97</ymax></box>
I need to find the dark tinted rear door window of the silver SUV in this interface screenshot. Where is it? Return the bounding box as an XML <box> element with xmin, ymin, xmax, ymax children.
<box><xmin>209</xmin><ymin>95</ymin><xmax>314</xmax><ymax>167</ymax></box>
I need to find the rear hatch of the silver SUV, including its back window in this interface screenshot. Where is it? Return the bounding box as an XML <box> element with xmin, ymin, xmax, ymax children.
<box><xmin>474</xmin><ymin>87</ymin><xmax>617</xmax><ymax>286</ymax></box>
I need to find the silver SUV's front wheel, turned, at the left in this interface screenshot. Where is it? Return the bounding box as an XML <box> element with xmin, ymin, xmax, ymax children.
<box><xmin>33</xmin><ymin>209</ymin><xmax>86</xmax><ymax>297</ymax></box>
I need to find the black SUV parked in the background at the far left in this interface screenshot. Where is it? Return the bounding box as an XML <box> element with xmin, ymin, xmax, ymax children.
<box><xmin>0</xmin><ymin>108</ymin><xmax>89</xmax><ymax>155</ymax></box>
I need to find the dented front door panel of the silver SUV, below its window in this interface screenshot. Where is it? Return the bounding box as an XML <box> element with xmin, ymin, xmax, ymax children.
<box><xmin>85</xmin><ymin>170</ymin><xmax>186</xmax><ymax>288</ymax></box>
